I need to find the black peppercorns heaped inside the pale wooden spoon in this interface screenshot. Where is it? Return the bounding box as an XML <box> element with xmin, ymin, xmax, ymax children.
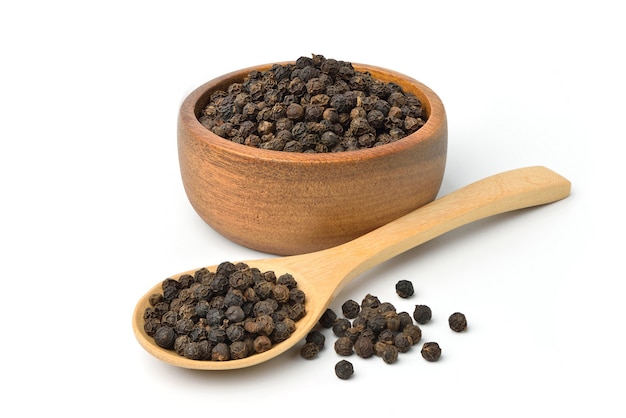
<box><xmin>143</xmin><ymin>262</ymin><xmax>306</xmax><ymax>361</ymax></box>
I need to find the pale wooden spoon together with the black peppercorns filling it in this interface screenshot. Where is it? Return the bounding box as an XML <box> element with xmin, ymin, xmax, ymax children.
<box><xmin>132</xmin><ymin>166</ymin><xmax>571</xmax><ymax>370</ymax></box>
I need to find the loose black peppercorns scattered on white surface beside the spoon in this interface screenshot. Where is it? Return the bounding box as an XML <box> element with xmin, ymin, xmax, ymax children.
<box><xmin>300</xmin><ymin>280</ymin><xmax>467</xmax><ymax>379</ymax></box>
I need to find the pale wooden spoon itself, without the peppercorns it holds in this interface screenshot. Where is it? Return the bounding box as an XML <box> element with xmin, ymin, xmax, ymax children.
<box><xmin>132</xmin><ymin>166</ymin><xmax>571</xmax><ymax>370</ymax></box>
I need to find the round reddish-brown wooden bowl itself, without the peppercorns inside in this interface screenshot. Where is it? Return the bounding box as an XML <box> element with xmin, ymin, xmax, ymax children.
<box><xmin>178</xmin><ymin>63</ymin><xmax>447</xmax><ymax>255</ymax></box>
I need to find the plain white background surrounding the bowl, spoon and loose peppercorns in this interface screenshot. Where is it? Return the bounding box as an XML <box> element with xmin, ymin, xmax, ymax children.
<box><xmin>0</xmin><ymin>0</ymin><xmax>626</xmax><ymax>417</ymax></box>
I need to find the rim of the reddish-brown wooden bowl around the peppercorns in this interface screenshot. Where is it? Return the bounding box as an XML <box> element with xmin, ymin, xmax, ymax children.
<box><xmin>178</xmin><ymin>61</ymin><xmax>447</xmax><ymax>163</ymax></box>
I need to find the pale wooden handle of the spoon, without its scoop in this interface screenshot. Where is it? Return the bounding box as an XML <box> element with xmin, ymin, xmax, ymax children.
<box><xmin>327</xmin><ymin>166</ymin><xmax>571</xmax><ymax>287</ymax></box>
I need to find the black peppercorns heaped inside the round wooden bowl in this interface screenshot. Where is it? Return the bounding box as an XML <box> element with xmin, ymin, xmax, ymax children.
<box><xmin>198</xmin><ymin>55</ymin><xmax>427</xmax><ymax>153</ymax></box>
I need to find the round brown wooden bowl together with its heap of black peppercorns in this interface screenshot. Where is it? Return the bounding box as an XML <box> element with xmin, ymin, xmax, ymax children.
<box><xmin>178</xmin><ymin>55</ymin><xmax>447</xmax><ymax>255</ymax></box>
